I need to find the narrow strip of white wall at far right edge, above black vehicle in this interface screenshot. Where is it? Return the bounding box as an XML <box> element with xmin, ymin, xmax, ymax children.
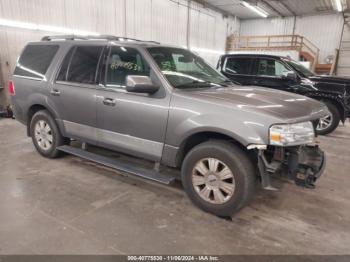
<box><xmin>337</xmin><ymin>18</ymin><xmax>350</xmax><ymax>76</ymax></box>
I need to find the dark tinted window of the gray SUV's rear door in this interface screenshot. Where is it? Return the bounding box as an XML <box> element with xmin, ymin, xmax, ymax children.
<box><xmin>57</xmin><ymin>46</ymin><xmax>103</xmax><ymax>84</ymax></box>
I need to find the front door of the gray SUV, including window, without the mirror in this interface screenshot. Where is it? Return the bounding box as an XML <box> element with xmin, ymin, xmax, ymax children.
<box><xmin>96</xmin><ymin>46</ymin><xmax>170</xmax><ymax>161</ymax></box>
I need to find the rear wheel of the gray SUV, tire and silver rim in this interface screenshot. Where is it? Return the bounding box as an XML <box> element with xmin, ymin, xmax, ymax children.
<box><xmin>30</xmin><ymin>110</ymin><xmax>69</xmax><ymax>158</ymax></box>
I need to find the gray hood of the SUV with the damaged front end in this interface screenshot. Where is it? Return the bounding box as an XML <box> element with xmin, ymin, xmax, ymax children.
<box><xmin>184</xmin><ymin>86</ymin><xmax>328</xmax><ymax>122</ymax></box>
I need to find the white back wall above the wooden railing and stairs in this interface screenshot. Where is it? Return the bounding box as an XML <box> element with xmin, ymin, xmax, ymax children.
<box><xmin>240</xmin><ymin>14</ymin><xmax>343</xmax><ymax>63</ymax></box>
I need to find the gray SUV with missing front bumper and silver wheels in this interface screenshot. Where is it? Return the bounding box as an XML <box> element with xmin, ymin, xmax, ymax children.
<box><xmin>9</xmin><ymin>36</ymin><xmax>329</xmax><ymax>216</ymax></box>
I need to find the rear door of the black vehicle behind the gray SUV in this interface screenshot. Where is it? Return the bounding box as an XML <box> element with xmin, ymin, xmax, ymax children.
<box><xmin>222</xmin><ymin>56</ymin><xmax>254</xmax><ymax>85</ymax></box>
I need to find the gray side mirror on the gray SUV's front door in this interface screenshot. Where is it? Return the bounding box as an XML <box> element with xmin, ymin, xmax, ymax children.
<box><xmin>126</xmin><ymin>75</ymin><xmax>159</xmax><ymax>94</ymax></box>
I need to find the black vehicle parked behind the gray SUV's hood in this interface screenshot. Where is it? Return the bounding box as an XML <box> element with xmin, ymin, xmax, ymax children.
<box><xmin>217</xmin><ymin>54</ymin><xmax>350</xmax><ymax>135</ymax></box>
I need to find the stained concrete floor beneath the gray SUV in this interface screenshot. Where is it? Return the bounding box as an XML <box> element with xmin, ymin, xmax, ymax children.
<box><xmin>0</xmin><ymin>119</ymin><xmax>350</xmax><ymax>254</ymax></box>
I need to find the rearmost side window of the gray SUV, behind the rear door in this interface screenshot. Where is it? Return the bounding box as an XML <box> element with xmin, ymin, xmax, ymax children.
<box><xmin>14</xmin><ymin>45</ymin><xmax>58</xmax><ymax>79</ymax></box>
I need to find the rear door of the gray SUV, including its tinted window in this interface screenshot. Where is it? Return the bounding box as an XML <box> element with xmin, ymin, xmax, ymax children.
<box><xmin>50</xmin><ymin>45</ymin><xmax>104</xmax><ymax>143</ymax></box>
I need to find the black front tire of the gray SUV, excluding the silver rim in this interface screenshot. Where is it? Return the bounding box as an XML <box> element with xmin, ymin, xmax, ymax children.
<box><xmin>181</xmin><ymin>141</ymin><xmax>252</xmax><ymax>216</ymax></box>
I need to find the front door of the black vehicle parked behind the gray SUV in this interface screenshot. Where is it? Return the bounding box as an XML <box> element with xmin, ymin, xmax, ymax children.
<box><xmin>253</xmin><ymin>57</ymin><xmax>297</xmax><ymax>91</ymax></box>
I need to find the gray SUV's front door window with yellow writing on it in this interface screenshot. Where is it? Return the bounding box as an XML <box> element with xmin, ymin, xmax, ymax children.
<box><xmin>106</xmin><ymin>46</ymin><xmax>150</xmax><ymax>87</ymax></box>
